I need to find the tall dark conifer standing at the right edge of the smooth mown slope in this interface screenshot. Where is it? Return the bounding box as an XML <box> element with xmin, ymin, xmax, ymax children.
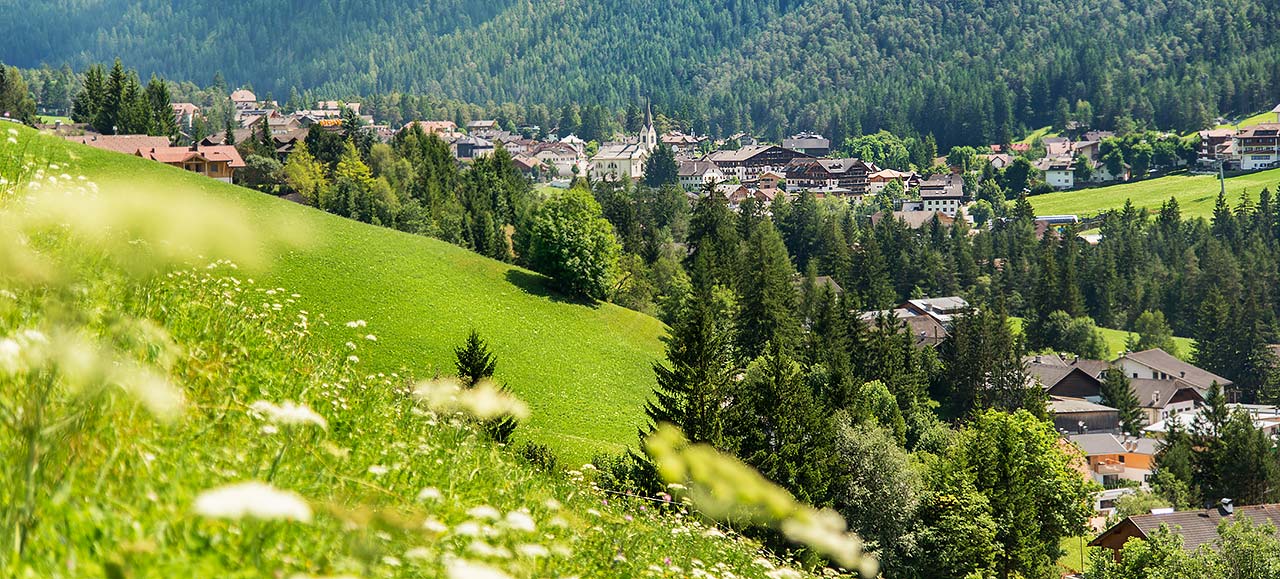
<box><xmin>641</xmin><ymin>255</ymin><xmax>733</xmax><ymax>448</ymax></box>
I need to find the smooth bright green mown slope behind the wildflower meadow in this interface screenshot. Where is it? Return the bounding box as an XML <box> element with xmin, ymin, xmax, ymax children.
<box><xmin>33</xmin><ymin>128</ymin><xmax>666</xmax><ymax>460</ymax></box>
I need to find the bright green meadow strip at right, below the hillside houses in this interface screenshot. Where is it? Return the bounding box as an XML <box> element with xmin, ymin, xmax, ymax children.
<box><xmin>1030</xmin><ymin>169</ymin><xmax>1280</xmax><ymax>218</ymax></box>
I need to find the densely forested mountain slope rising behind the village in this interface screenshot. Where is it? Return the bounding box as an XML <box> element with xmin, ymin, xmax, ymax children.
<box><xmin>0</xmin><ymin>0</ymin><xmax>1280</xmax><ymax>146</ymax></box>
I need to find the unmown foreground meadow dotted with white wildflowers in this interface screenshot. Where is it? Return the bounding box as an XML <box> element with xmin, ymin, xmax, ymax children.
<box><xmin>0</xmin><ymin>124</ymin><xmax>834</xmax><ymax>579</ymax></box>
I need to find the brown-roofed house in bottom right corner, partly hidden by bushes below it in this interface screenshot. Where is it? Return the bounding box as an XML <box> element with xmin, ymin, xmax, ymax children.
<box><xmin>1089</xmin><ymin>498</ymin><xmax>1280</xmax><ymax>560</ymax></box>
